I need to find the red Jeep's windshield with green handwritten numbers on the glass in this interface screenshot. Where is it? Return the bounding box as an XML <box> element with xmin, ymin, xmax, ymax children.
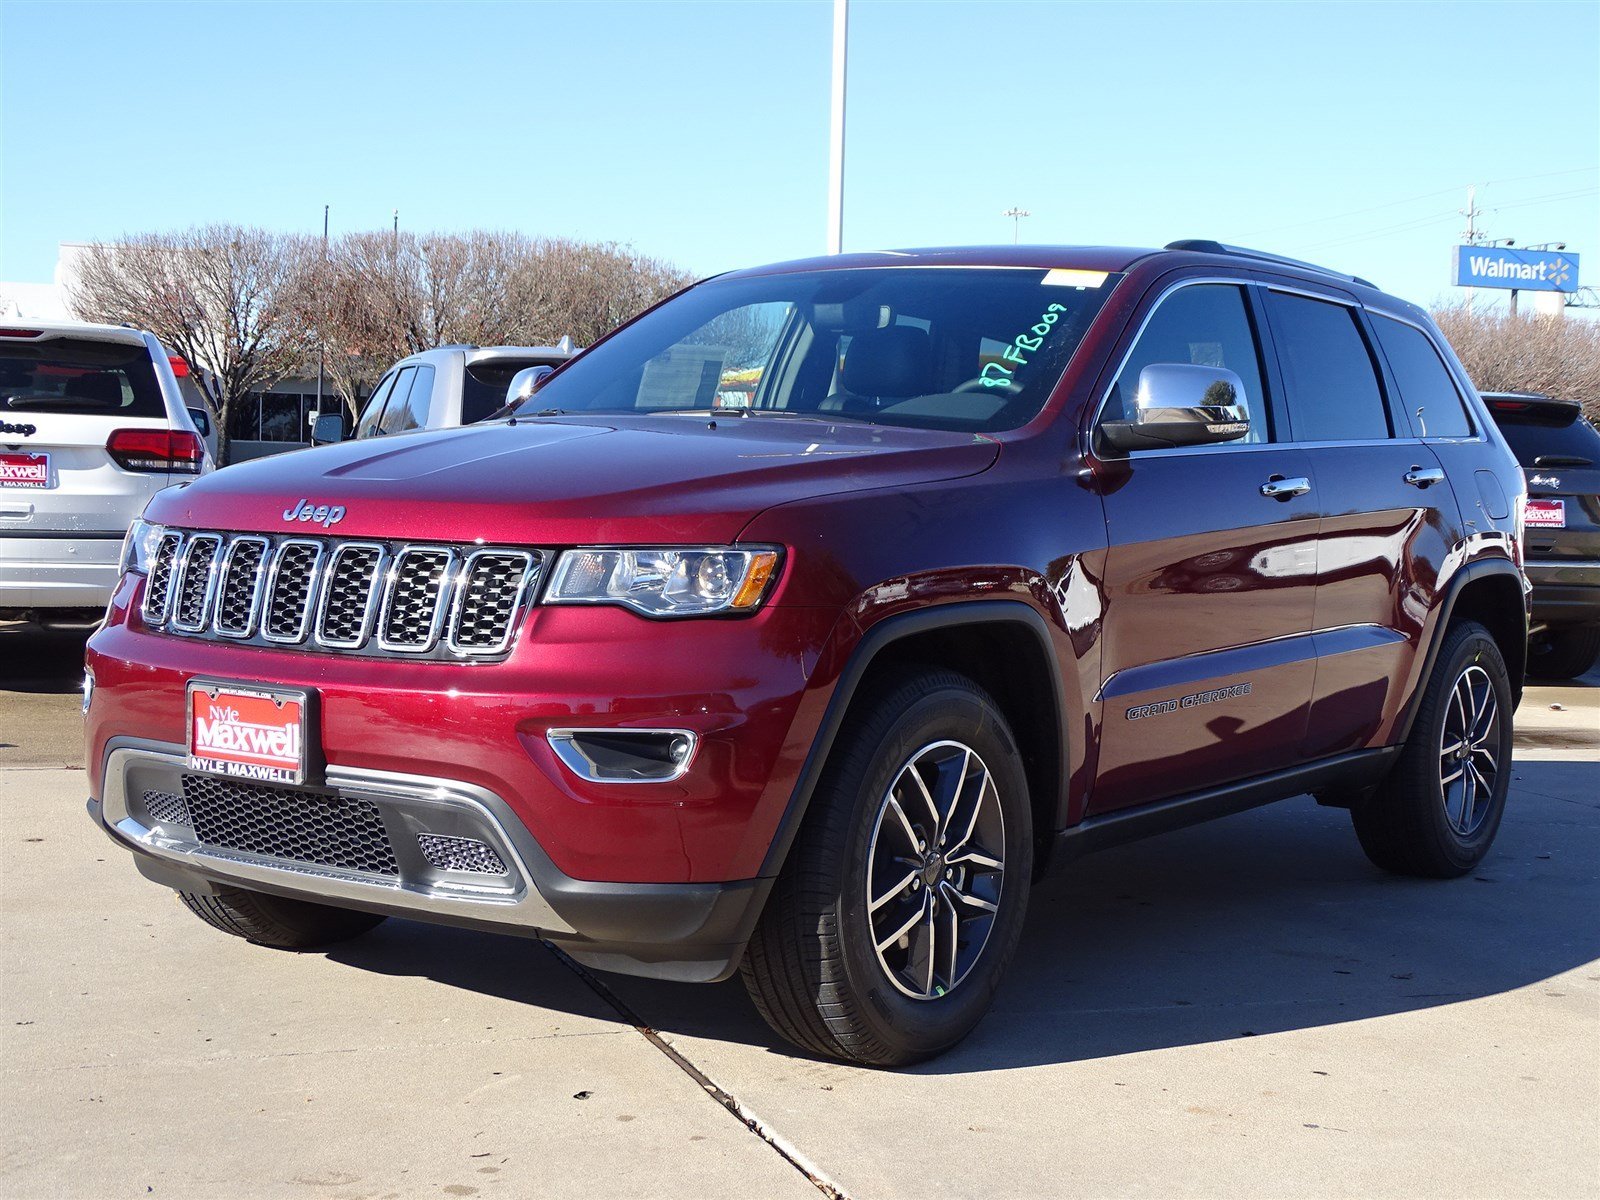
<box><xmin>517</xmin><ymin>267</ymin><xmax>1120</xmax><ymax>432</ymax></box>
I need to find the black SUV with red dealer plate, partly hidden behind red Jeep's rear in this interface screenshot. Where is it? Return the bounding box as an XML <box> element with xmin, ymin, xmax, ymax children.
<box><xmin>1483</xmin><ymin>392</ymin><xmax>1600</xmax><ymax>678</ymax></box>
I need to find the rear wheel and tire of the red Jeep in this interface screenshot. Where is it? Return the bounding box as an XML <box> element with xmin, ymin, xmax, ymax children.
<box><xmin>1350</xmin><ymin>621</ymin><xmax>1512</xmax><ymax>878</ymax></box>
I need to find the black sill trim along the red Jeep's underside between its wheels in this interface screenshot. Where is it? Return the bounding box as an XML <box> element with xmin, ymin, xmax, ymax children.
<box><xmin>1056</xmin><ymin>746</ymin><xmax>1402</xmax><ymax>861</ymax></box>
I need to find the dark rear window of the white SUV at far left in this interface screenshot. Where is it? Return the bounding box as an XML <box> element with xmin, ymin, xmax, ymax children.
<box><xmin>0</xmin><ymin>338</ymin><xmax>166</xmax><ymax>416</ymax></box>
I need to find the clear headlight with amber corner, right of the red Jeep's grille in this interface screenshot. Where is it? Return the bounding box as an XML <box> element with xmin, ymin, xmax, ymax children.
<box><xmin>544</xmin><ymin>546</ymin><xmax>778</xmax><ymax>616</ymax></box>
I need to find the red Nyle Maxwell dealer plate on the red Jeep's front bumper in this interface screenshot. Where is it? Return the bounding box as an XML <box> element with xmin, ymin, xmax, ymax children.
<box><xmin>189</xmin><ymin>682</ymin><xmax>310</xmax><ymax>784</ymax></box>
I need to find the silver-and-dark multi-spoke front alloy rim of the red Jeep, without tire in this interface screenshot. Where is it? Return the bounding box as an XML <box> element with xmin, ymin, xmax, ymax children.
<box><xmin>867</xmin><ymin>741</ymin><xmax>1005</xmax><ymax>1000</ymax></box>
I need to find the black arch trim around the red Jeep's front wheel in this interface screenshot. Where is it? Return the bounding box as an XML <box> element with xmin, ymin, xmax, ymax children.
<box><xmin>762</xmin><ymin>600</ymin><xmax>1069</xmax><ymax>878</ymax></box>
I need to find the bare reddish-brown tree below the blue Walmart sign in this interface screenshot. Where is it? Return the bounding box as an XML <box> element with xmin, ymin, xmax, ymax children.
<box><xmin>1434</xmin><ymin>304</ymin><xmax>1600</xmax><ymax>419</ymax></box>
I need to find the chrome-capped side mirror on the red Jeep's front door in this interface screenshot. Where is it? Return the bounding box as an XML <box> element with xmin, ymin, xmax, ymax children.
<box><xmin>1101</xmin><ymin>363</ymin><xmax>1250</xmax><ymax>451</ymax></box>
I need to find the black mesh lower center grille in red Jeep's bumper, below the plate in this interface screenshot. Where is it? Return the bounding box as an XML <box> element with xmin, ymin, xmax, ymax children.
<box><xmin>184</xmin><ymin>774</ymin><xmax>400</xmax><ymax>875</ymax></box>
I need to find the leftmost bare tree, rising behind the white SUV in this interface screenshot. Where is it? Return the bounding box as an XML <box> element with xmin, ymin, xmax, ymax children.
<box><xmin>67</xmin><ymin>226</ymin><xmax>314</xmax><ymax>464</ymax></box>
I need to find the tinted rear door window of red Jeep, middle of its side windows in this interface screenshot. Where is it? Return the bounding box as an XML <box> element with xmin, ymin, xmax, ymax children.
<box><xmin>1269</xmin><ymin>291</ymin><xmax>1390</xmax><ymax>442</ymax></box>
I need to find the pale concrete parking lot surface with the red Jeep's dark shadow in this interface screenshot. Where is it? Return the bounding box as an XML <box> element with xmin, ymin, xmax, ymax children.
<box><xmin>0</xmin><ymin>630</ymin><xmax>1600</xmax><ymax>1200</ymax></box>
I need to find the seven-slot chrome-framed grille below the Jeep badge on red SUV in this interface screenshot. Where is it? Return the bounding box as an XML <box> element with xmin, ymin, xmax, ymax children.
<box><xmin>141</xmin><ymin>530</ymin><xmax>544</xmax><ymax>659</ymax></box>
